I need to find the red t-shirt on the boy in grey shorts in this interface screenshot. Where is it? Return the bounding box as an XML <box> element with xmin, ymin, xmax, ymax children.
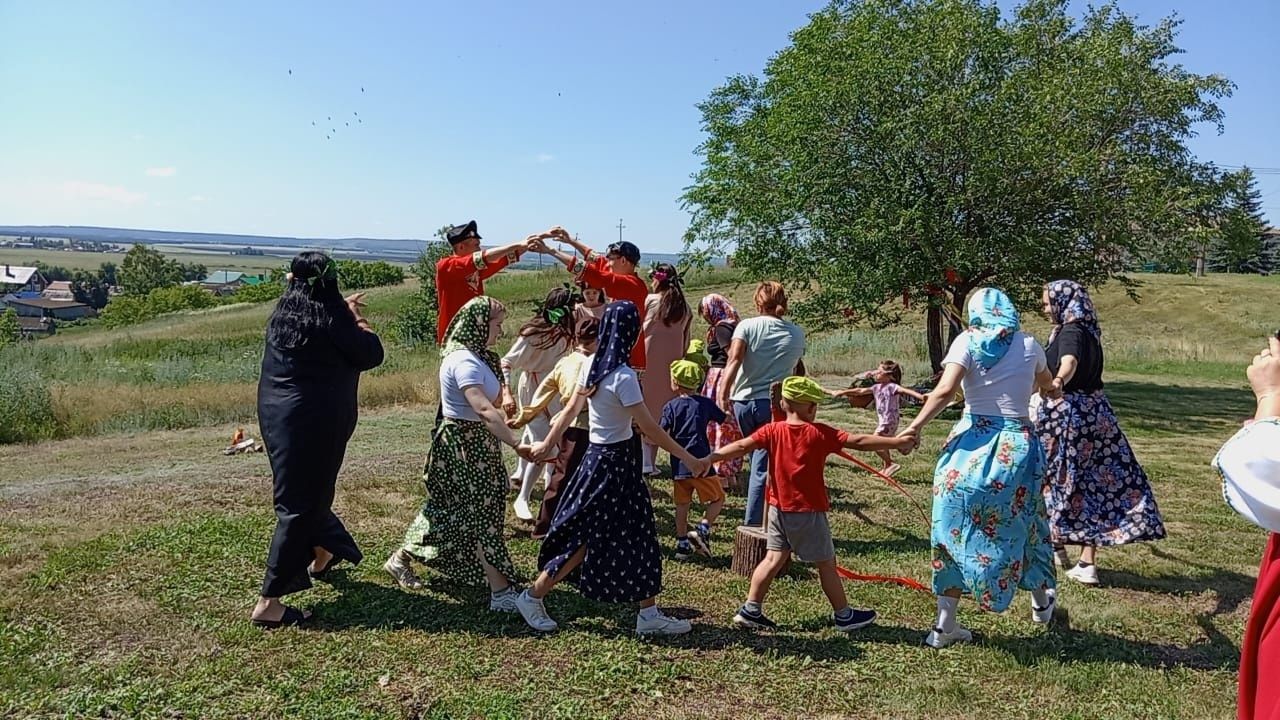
<box><xmin>751</xmin><ymin>421</ymin><xmax>849</xmax><ymax>512</ymax></box>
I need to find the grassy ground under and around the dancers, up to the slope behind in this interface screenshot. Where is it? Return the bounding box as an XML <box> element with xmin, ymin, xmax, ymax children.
<box><xmin>0</xmin><ymin>274</ymin><xmax>1280</xmax><ymax>719</ymax></box>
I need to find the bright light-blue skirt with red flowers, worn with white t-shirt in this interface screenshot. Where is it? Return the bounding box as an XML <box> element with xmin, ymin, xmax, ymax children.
<box><xmin>931</xmin><ymin>415</ymin><xmax>1056</xmax><ymax>612</ymax></box>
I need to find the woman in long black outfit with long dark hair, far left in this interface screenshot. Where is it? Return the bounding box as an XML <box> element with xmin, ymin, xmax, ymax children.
<box><xmin>252</xmin><ymin>251</ymin><xmax>383</xmax><ymax>628</ymax></box>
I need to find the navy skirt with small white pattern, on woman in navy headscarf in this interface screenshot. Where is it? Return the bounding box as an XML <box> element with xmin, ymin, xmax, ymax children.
<box><xmin>538</xmin><ymin>436</ymin><xmax>662</xmax><ymax>602</ymax></box>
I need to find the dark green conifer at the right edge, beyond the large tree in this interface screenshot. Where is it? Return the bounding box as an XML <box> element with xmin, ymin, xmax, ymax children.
<box><xmin>1208</xmin><ymin>168</ymin><xmax>1276</xmax><ymax>273</ymax></box>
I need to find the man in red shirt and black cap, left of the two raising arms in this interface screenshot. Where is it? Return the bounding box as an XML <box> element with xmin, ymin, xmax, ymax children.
<box><xmin>435</xmin><ymin>220</ymin><xmax>529</xmax><ymax>345</ymax></box>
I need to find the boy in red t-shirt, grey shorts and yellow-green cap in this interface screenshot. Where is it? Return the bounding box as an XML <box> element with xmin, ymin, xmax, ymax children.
<box><xmin>707</xmin><ymin>377</ymin><xmax>915</xmax><ymax>633</ymax></box>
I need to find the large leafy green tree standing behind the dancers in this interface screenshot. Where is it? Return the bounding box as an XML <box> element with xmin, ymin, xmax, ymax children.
<box><xmin>684</xmin><ymin>0</ymin><xmax>1231</xmax><ymax>366</ymax></box>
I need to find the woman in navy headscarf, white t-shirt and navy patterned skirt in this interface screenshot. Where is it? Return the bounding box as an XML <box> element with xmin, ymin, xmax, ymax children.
<box><xmin>516</xmin><ymin>300</ymin><xmax>707</xmax><ymax>635</ymax></box>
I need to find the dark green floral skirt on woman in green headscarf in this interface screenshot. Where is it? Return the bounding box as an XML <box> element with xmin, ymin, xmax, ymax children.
<box><xmin>404</xmin><ymin>418</ymin><xmax>518</xmax><ymax>584</ymax></box>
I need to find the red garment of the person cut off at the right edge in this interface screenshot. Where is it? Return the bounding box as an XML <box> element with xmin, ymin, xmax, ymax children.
<box><xmin>1236</xmin><ymin>533</ymin><xmax>1280</xmax><ymax>720</ymax></box>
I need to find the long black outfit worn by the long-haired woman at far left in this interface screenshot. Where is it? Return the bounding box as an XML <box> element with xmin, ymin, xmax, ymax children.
<box><xmin>257</xmin><ymin>315</ymin><xmax>383</xmax><ymax>597</ymax></box>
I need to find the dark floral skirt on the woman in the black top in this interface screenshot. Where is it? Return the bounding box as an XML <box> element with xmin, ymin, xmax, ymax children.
<box><xmin>1036</xmin><ymin>389</ymin><xmax>1165</xmax><ymax>546</ymax></box>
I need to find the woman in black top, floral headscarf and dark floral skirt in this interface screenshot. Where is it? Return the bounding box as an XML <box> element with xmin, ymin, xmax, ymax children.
<box><xmin>1036</xmin><ymin>281</ymin><xmax>1165</xmax><ymax>585</ymax></box>
